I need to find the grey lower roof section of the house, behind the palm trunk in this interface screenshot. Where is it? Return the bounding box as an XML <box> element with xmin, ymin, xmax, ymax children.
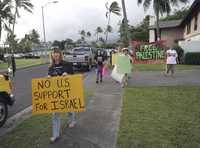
<box><xmin>149</xmin><ymin>20</ymin><xmax>182</xmax><ymax>29</ymax></box>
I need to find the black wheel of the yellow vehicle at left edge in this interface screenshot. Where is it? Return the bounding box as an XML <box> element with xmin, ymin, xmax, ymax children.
<box><xmin>0</xmin><ymin>101</ymin><xmax>8</xmax><ymax>127</ymax></box>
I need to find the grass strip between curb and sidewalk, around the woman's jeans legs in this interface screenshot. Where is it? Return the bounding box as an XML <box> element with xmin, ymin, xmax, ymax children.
<box><xmin>0</xmin><ymin>92</ymin><xmax>92</xmax><ymax>148</ymax></box>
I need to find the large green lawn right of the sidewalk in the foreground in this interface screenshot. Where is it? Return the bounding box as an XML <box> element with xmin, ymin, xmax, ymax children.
<box><xmin>117</xmin><ymin>86</ymin><xmax>200</xmax><ymax>148</ymax></box>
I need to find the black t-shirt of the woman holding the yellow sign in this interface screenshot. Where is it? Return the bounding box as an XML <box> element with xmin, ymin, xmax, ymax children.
<box><xmin>48</xmin><ymin>61</ymin><xmax>74</xmax><ymax>76</ymax></box>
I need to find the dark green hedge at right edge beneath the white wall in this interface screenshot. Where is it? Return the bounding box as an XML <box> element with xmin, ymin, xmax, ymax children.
<box><xmin>184</xmin><ymin>52</ymin><xmax>200</xmax><ymax>65</ymax></box>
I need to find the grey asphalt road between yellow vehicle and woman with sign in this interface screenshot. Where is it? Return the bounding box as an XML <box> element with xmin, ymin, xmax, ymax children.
<box><xmin>9</xmin><ymin>65</ymin><xmax>92</xmax><ymax>117</ymax></box>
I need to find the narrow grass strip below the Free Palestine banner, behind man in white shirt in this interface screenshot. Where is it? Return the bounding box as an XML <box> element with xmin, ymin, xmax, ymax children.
<box><xmin>133</xmin><ymin>64</ymin><xmax>194</xmax><ymax>71</ymax></box>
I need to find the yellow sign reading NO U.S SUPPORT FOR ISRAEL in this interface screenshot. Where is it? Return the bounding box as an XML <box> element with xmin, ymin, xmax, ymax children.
<box><xmin>32</xmin><ymin>75</ymin><xmax>85</xmax><ymax>114</ymax></box>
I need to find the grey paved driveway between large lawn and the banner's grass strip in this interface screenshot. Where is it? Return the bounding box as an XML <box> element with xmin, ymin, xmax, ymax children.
<box><xmin>129</xmin><ymin>69</ymin><xmax>200</xmax><ymax>86</ymax></box>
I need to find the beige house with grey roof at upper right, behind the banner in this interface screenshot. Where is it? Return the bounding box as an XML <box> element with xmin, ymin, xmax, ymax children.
<box><xmin>149</xmin><ymin>0</ymin><xmax>200</xmax><ymax>51</ymax></box>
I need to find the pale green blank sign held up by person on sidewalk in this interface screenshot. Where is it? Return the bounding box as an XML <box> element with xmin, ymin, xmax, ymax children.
<box><xmin>117</xmin><ymin>55</ymin><xmax>132</xmax><ymax>74</ymax></box>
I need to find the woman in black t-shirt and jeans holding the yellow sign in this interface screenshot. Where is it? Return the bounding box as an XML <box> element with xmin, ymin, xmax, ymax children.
<box><xmin>48</xmin><ymin>48</ymin><xmax>76</xmax><ymax>143</ymax></box>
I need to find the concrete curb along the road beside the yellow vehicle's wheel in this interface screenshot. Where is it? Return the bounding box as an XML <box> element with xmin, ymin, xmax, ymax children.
<box><xmin>0</xmin><ymin>105</ymin><xmax>32</xmax><ymax>137</ymax></box>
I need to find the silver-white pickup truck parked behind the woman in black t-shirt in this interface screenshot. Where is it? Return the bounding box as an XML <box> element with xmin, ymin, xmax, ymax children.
<box><xmin>64</xmin><ymin>47</ymin><xmax>94</xmax><ymax>71</ymax></box>
